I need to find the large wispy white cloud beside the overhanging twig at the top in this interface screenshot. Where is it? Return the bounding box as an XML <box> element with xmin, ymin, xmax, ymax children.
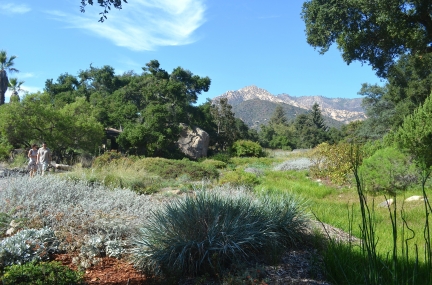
<box><xmin>48</xmin><ymin>0</ymin><xmax>206</xmax><ymax>51</ymax></box>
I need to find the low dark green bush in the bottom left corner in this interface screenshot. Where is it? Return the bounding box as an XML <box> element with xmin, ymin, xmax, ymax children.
<box><xmin>1</xmin><ymin>261</ymin><xmax>84</xmax><ymax>285</ymax></box>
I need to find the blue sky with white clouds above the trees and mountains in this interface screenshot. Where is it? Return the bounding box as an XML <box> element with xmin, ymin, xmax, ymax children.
<box><xmin>0</xmin><ymin>0</ymin><xmax>381</xmax><ymax>103</ymax></box>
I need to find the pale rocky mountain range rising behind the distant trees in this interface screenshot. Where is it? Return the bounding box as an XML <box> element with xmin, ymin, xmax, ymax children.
<box><xmin>213</xmin><ymin>85</ymin><xmax>366</xmax><ymax>128</ymax></box>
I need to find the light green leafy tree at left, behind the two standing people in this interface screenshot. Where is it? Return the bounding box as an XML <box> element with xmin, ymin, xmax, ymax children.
<box><xmin>0</xmin><ymin>93</ymin><xmax>104</xmax><ymax>160</ymax></box>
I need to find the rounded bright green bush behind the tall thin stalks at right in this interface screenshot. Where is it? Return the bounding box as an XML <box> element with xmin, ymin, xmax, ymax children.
<box><xmin>359</xmin><ymin>147</ymin><xmax>418</xmax><ymax>193</ymax></box>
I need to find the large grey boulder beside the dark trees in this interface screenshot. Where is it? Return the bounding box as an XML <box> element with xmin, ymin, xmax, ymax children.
<box><xmin>177</xmin><ymin>124</ymin><xmax>210</xmax><ymax>159</ymax></box>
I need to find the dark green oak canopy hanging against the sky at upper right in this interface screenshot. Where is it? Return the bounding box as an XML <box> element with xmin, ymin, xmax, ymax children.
<box><xmin>301</xmin><ymin>0</ymin><xmax>432</xmax><ymax>77</ymax></box>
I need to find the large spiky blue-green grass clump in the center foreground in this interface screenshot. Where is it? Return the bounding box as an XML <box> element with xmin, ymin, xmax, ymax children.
<box><xmin>133</xmin><ymin>188</ymin><xmax>307</xmax><ymax>276</ymax></box>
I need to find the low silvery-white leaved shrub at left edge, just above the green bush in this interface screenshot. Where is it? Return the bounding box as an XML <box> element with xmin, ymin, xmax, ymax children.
<box><xmin>0</xmin><ymin>228</ymin><xmax>59</xmax><ymax>268</ymax></box>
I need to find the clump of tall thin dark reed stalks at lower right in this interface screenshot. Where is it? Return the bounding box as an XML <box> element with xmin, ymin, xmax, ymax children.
<box><xmin>351</xmin><ymin>146</ymin><xmax>432</xmax><ymax>285</ymax></box>
